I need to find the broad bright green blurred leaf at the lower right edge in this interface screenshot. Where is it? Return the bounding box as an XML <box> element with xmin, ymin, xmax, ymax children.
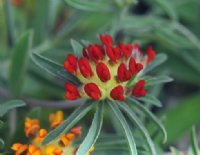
<box><xmin>162</xmin><ymin>93</ymin><xmax>200</xmax><ymax>146</ymax></box>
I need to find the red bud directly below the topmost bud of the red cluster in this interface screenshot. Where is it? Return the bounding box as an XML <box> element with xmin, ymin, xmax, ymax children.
<box><xmin>106</xmin><ymin>46</ymin><xmax>121</xmax><ymax>62</ymax></box>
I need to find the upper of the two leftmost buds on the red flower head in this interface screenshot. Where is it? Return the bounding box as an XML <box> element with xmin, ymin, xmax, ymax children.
<box><xmin>64</xmin><ymin>54</ymin><xmax>77</xmax><ymax>74</ymax></box>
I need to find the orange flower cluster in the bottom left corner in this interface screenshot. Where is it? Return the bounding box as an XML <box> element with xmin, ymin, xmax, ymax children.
<box><xmin>11</xmin><ymin>111</ymin><xmax>94</xmax><ymax>155</ymax></box>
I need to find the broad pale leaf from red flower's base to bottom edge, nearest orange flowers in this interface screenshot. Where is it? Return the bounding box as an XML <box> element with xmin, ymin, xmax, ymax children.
<box><xmin>76</xmin><ymin>102</ymin><xmax>104</xmax><ymax>155</ymax></box>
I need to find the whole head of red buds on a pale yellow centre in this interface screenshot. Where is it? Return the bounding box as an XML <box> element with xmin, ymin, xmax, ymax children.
<box><xmin>64</xmin><ymin>35</ymin><xmax>156</xmax><ymax>101</ymax></box>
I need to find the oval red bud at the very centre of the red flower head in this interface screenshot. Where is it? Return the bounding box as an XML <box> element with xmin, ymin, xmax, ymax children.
<box><xmin>96</xmin><ymin>62</ymin><xmax>110</xmax><ymax>82</ymax></box>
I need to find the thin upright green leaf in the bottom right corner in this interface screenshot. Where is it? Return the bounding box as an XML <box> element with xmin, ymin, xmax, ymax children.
<box><xmin>190</xmin><ymin>126</ymin><xmax>199</xmax><ymax>155</ymax></box>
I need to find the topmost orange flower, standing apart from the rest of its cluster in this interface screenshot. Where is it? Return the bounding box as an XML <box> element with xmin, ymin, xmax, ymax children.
<box><xmin>49</xmin><ymin>111</ymin><xmax>63</xmax><ymax>129</ymax></box>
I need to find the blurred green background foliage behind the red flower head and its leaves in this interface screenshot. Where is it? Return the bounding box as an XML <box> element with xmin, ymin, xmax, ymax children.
<box><xmin>0</xmin><ymin>0</ymin><xmax>200</xmax><ymax>154</ymax></box>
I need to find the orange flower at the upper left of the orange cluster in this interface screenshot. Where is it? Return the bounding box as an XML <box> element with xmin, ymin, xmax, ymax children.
<box><xmin>24</xmin><ymin>118</ymin><xmax>40</xmax><ymax>137</ymax></box>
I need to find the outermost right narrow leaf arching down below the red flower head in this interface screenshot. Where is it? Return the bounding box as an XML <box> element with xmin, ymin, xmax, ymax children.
<box><xmin>127</xmin><ymin>98</ymin><xmax>167</xmax><ymax>143</ymax></box>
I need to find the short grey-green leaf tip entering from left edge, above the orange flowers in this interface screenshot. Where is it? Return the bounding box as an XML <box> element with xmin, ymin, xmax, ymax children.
<box><xmin>0</xmin><ymin>100</ymin><xmax>26</xmax><ymax>117</ymax></box>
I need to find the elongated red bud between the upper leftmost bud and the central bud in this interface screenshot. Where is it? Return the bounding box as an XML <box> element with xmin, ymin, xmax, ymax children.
<box><xmin>78</xmin><ymin>57</ymin><xmax>93</xmax><ymax>78</ymax></box>
